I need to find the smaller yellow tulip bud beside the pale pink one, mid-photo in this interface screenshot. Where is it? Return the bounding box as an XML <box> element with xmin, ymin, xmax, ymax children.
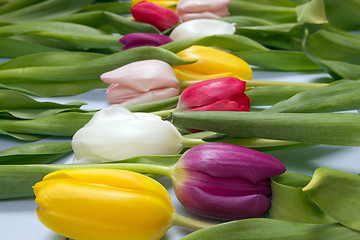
<box><xmin>173</xmin><ymin>45</ymin><xmax>252</xmax><ymax>81</ymax></box>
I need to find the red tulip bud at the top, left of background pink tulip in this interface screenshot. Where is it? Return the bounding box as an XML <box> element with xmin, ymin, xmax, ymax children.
<box><xmin>130</xmin><ymin>1</ymin><xmax>180</xmax><ymax>31</ymax></box>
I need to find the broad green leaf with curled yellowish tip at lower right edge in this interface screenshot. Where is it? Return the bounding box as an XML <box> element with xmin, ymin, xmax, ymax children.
<box><xmin>303</xmin><ymin>168</ymin><xmax>360</xmax><ymax>231</ymax></box>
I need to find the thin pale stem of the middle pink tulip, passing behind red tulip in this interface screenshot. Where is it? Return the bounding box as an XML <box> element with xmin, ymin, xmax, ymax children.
<box><xmin>180</xmin><ymin>80</ymin><xmax>329</xmax><ymax>88</ymax></box>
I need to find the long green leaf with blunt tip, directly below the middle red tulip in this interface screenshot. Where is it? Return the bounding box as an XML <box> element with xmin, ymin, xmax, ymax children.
<box><xmin>172</xmin><ymin>112</ymin><xmax>360</xmax><ymax>146</ymax></box>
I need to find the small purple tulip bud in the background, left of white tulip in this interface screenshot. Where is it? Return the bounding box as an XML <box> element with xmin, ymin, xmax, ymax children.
<box><xmin>119</xmin><ymin>33</ymin><xmax>173</xmax><ymax>50</ymax></box>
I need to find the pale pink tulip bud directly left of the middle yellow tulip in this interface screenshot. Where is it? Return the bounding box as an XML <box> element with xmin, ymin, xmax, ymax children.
<box><xmin>100</xmin><ymin>59</ymin><xmax>179</xmax><ymax>106</ymax></box>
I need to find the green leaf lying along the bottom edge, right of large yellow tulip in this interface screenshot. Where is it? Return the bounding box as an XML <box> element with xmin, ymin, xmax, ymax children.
<box><xmin>182</xmin><ymin>218</ymin><xmax>360</xmax><ymax>240</ymax></box>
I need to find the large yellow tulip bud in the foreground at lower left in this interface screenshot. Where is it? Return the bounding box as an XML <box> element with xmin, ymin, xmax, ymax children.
<box><xmin>33</xmin><ymin>169</ymin><xmax>175</xmax><ymax>240</ymax></box>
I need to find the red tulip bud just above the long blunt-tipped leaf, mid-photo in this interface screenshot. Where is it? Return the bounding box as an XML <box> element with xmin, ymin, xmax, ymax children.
<box><xmin>177</xmin><ymin>77</ymin><xmax>250</xmax><ymax>112</ymax></box>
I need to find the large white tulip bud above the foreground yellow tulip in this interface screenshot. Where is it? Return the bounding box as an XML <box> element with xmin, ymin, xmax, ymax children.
<box><xmin>71</xmin><ymin>105</ymin><xmax>183</xmax><ymax>163</ymax></box>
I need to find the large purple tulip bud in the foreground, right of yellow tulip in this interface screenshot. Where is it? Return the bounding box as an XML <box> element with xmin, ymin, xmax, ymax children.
<box><xmin>172</xmin><ymin>143</ymin><xmax>286</xmax><ymax>220</ymax></box>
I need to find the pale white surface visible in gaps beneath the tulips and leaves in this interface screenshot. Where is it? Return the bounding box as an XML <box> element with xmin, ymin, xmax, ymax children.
<box><xmin>0</xmin><ymin>71</ymin><xmax>360</xmax><ymax>240</ymax></box>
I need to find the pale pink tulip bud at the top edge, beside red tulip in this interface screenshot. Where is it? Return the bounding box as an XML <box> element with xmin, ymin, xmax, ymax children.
<box><xmin>176</xmin><ymin>0</ymin><xmax>230</xmax><ymax>21</ymax></box>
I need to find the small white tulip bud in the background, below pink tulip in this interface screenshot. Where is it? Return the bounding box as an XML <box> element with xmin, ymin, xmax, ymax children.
<box><xmin>170</xmin><ymin>19</ymin><xmax>236</xmax><ymax>41</ymax></box>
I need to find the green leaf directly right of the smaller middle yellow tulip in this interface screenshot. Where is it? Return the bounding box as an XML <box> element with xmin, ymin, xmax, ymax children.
<box><xmin>233</xmin><ymin>50</ymin><xmax>321</xmax><ymax>71</ymax></box>
